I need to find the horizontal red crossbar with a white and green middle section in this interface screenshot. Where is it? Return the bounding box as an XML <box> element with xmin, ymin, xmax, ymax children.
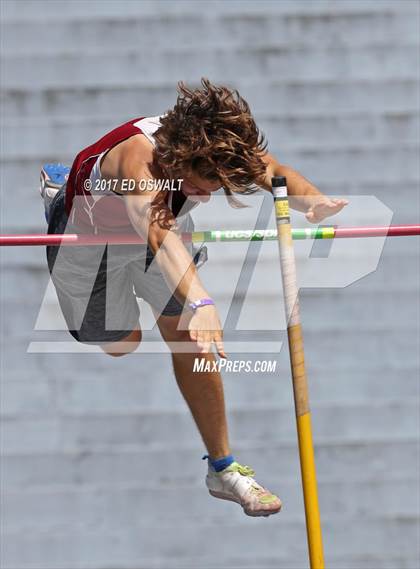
<box><xmin>0</xmin><ymin>225</ymin><xmax>420</xmax><ymax>246</ymax></box>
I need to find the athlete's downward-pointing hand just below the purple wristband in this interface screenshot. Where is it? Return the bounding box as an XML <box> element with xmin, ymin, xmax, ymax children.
<box><xmin>188</xmin><ymin>305</ymin><xmax>226</xmax><ymax>358</ymax></box>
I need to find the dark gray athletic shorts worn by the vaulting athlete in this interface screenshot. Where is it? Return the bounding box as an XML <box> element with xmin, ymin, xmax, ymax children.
<box><xmin>47</xmin><ymin>186</ymin><xmax>206</xmax><ymax>344</ymax></box>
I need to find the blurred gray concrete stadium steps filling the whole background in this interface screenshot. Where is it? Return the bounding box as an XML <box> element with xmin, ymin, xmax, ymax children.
<box><xmin>0</xmin><ymin>0</ymin><xmax>419</xmax><ymax>569</ymax></box>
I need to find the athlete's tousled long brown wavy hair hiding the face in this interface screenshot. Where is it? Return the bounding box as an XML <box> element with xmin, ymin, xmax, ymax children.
<box><xmin>154</xmin><ymin>77</ymin><xmax>267</xmax><ymax>225</ymax></box>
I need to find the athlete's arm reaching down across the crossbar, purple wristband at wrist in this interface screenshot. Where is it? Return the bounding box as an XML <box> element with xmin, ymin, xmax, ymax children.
<box><xmin>118</xmin><ymin>140</ymin><xmax>226</xmax><ymax>357</ymax></box>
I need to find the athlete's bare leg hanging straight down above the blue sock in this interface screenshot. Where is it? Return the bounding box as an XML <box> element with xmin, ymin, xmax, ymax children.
<box><xmin>157</xmin><ymin>310</ymin><xmax>230</xmax><ymax>459</ymax></box>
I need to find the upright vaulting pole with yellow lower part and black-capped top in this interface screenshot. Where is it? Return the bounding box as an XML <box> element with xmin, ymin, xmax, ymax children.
<box><xmin>272</xmin><ymin>176</ymin><xmax>325</xmax><ymax>569</ymax></box>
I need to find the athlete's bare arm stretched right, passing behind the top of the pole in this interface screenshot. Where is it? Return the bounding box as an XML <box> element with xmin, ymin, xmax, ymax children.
<box><xmin>261</xmin><ymin>153</ymin><xmax>349</xmax><ymax>223</ymax></box>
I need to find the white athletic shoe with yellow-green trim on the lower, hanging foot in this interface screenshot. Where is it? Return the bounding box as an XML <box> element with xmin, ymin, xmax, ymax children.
<box><xmin>206</xmin><ymin>462</ymin><xmax>281</xmax><ymax>516</ymax></box>
